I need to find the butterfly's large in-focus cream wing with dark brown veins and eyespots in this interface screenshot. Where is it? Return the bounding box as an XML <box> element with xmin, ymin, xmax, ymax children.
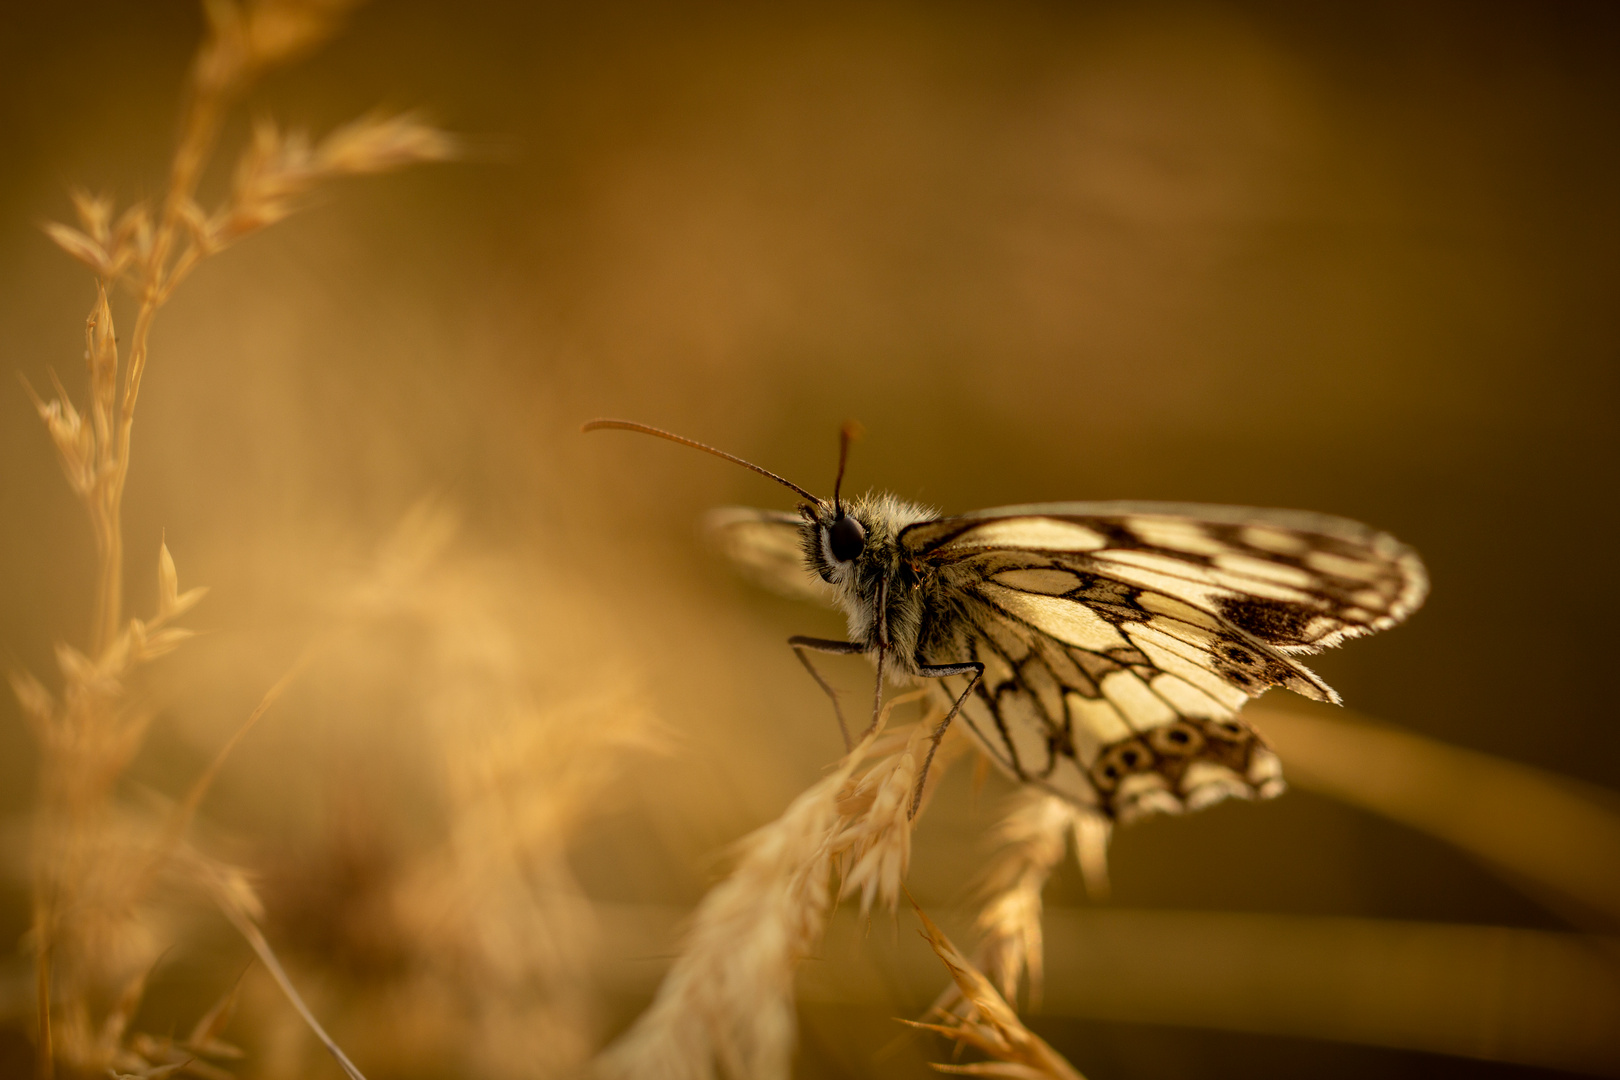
<box><xmin>899</xmin><ymin>504</ymin><xmax>1427</xmax><ymax>819</ymax></box>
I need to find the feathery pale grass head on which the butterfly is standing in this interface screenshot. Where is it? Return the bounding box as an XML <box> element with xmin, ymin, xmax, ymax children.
<box><xmin>596</xmin><ymin>691</ymin><xmax>943</xmax><ymax>1080</ymax></box>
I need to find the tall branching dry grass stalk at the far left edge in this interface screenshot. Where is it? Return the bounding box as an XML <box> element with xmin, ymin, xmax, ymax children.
<box><xmin>11</xmin><ymin>0</ymin><xmax>452</xmax><ymax>1077</ymax></box>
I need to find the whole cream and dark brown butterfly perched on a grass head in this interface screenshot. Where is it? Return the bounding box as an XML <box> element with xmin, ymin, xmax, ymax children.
<box><xmin>585</xmin><ymin>419</ymin><xmax>1429</xmax><ymax>821</ymax></box>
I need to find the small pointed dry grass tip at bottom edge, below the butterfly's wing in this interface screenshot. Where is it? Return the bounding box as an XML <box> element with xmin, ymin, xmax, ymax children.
<box><xmin>902</xmin><ymin>908</ymin><xmax>1084</xmax><ymax>1080</ymax></box>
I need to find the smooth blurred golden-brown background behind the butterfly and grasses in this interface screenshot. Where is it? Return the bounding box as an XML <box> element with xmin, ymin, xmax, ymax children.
<box><xmin>0</xmin><ymin>0</ymin><xmax>1620</xmax><ymax>1078</ymax></box>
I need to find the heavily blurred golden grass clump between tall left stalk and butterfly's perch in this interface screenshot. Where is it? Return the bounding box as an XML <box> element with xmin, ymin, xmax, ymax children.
<box><xmin>327</xmin><ymin>507</ymin><xmax>664</xmax><ymax>1078</ymax></box>
